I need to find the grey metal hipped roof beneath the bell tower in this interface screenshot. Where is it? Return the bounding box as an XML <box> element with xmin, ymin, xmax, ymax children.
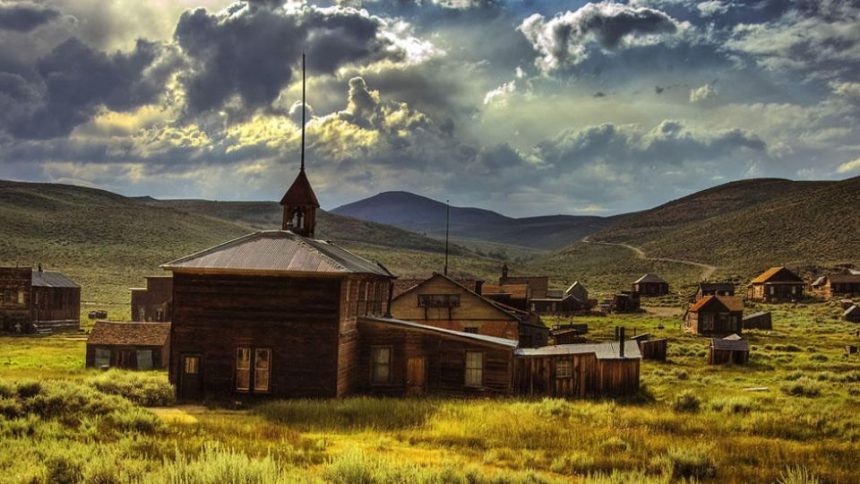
<box><xmin>161</xmin><ymin>230</ymin><xmax>392</xmax><ymax>277</ymax></box>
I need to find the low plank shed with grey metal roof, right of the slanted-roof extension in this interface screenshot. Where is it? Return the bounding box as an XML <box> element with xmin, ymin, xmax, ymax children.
<box><xmin>514</xmin><ymin>334</ymin><xmax>641</xmax><ymax>398</ymax></box>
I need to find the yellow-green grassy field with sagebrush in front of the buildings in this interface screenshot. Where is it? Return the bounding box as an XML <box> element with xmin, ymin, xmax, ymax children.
<box><xmin>0</xmin><ymin>303</ymin><xmax>860</xmax><ymax>483</ymax></box>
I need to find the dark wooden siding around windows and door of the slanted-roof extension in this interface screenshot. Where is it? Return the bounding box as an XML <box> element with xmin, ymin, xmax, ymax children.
<box><xmin>358</xmin><ymin>320</ymin><xmax>513</xmax><ymax>396</ymax></box>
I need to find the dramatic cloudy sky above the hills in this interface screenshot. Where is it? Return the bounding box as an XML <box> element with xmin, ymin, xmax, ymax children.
<box><xmin>0</xmin><ymin>0</ymin><xmax>860</xmax><ymax>216</ymax></box>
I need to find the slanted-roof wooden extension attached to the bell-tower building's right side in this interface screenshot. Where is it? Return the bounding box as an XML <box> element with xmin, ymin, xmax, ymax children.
<box><xmin>354</xmin><ymin>317</ymin><xmax>517</xmax><ymax>396</ymax></box>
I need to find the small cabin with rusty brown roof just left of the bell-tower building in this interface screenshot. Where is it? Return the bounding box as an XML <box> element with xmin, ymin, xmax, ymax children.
<box><xmin>86</xmin><ymin>321</ymin><xmax>170</xmax><ymax>370</ymax></box>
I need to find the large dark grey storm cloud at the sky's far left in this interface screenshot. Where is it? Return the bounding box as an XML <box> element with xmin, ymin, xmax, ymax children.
<box><xmin>6</xmin><ymin>38</ymin><xmax>175</xmax><ymax>138</ymax></box>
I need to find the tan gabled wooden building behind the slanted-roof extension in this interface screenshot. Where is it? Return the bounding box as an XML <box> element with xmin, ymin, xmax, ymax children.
<box><xmin>391</xmin><ymin>274</ymin><xmax>549</xmax><ymax>346</ymax></box>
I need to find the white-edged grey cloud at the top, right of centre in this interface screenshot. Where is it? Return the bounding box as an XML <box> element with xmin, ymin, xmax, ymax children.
<box><xmin>518</xmin><ymin>2</ymin><xmax>681</xmax><ymax>71</ymax></box>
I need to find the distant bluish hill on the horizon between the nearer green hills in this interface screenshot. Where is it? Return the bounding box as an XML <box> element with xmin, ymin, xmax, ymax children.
<box><xmin>332</xmin><ymin>192</ymin><xmax>617</xmax><ymax>250</ymax></box>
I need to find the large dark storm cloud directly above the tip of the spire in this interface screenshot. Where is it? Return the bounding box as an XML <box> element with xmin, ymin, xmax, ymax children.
<box><xmin>175</xmin><ymin>4</ymin><xmax>405</xmax><ymax>113</ymax></box>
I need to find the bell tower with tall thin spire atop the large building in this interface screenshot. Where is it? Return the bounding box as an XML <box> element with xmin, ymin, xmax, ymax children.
<box><xmin>281</xmin><ymin>54</ymin><xmax>320</xmax><ymax>237</ymax></box>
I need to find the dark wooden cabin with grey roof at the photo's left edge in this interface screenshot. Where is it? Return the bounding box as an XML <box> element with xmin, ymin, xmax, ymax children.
<box><xmin>0</xmin><ymin>266</ymin><xmax>81</xmax><ymax>333</ymax></box>
